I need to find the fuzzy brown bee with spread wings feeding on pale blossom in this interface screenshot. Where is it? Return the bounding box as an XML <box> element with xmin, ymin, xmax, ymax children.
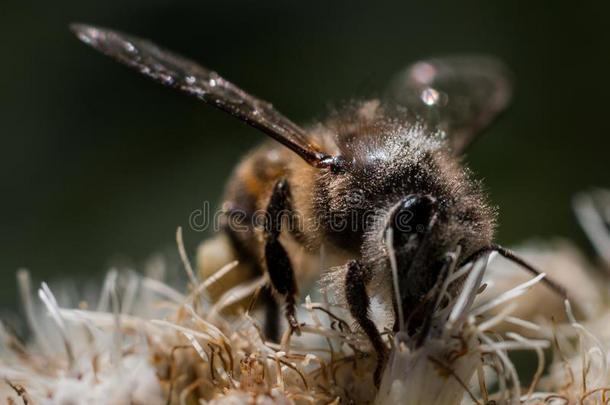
<box><xmin>72</xmin><ymin>25</ymin><xmax>565</xmax><ymax>383</ymax></box>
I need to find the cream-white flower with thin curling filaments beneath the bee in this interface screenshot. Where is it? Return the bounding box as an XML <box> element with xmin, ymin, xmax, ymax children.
<box><xmin>0</xmin><ymin>191</ymin><xmax>610</xmax><ymax>405</ymax></box>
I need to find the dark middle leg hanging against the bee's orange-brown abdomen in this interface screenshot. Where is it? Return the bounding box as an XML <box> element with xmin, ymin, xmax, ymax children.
<box><xmin>264</xmin><ymin>179</ymin><xmax>299</xmax><ymax>332</ymax></box>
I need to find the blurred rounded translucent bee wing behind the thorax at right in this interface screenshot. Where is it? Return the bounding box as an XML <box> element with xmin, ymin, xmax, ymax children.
<box><xmin>388</xmin><ymin>56</ymin><xmax>512</xmax><ymax>155</ymax></box>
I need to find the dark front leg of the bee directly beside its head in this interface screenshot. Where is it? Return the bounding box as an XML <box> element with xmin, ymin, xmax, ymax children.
<box><xmin>345</xmin><ymin>260</ymin><xmax>388</xmax><ymax>387</ymax></box>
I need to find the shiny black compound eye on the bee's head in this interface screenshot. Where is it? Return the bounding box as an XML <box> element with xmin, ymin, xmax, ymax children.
<box><xmin>390</xmin><ymin>194</ymin><xmax>436</xmax><ymax>236</ymax></box>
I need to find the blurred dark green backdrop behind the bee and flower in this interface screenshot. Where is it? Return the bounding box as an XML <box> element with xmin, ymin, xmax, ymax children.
<box><xmin>0</xmin><ymin>0</ymin><xmax>610</xmax><ymax>308</ymax></box>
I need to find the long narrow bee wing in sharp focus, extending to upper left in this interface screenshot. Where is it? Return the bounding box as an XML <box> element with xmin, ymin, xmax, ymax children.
<box><xmin>71</xmin><ymin>24</ymin><xmax>331</xmax><ymax>167</ymax></box>
